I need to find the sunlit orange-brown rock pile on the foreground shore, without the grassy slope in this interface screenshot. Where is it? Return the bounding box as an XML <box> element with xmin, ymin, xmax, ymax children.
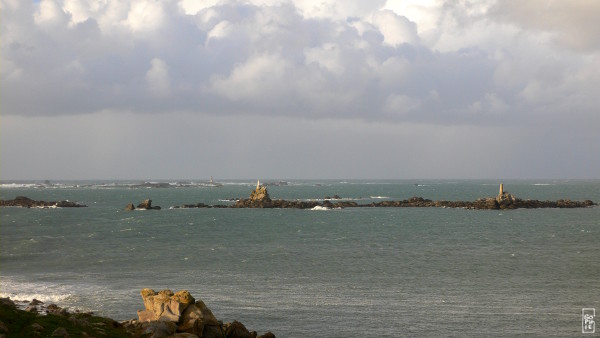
<box><xmin>123</xmin><ymin>289</ymin><xmax>275</xmax><ymax>338</ymax></box>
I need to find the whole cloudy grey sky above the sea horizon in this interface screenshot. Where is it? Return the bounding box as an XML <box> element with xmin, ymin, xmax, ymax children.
<box><xmin>0</xmin><ymin>0</ymin><xmax>600</xmax><ymax>181</ymax></box>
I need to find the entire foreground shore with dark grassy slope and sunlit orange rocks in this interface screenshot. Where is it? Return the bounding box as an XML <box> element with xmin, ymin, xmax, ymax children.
<box><xmin>0</xmin><ymin>289</ymin><xmax>275</xmax><ymax>338</ymax></box>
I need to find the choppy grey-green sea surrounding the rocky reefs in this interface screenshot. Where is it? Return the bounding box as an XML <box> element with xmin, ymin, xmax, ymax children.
<box><xmin>0</xmin><ymin>179</ymin><xmax>600</xmax><ymax>337</ymax></box>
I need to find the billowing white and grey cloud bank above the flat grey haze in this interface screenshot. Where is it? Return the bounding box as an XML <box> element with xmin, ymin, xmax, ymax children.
<box><xmin>0</xmin><ymin>0</ymin><xmax>600</xmax><ymax>131</ymax></box>
